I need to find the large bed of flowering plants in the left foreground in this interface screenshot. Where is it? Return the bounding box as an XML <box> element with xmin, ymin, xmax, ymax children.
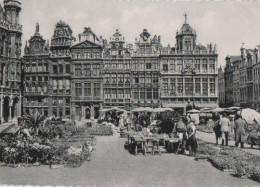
<box><xmin>0</xmin><ymin>117</ymin><xmax>95</xmax><ymax>167</ymax></box>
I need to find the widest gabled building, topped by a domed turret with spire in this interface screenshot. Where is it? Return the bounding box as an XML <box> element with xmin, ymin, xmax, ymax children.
<box><xmin>160</xmin><ymin>15</ymin><xmax>218</xmax><ymax>114</ymax></box>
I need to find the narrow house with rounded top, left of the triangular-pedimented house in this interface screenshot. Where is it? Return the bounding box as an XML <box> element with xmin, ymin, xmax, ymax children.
<box><xmin>49</xmin><ymin>21</ymin><xmax>75</xmax><ymax>118</ymax></box>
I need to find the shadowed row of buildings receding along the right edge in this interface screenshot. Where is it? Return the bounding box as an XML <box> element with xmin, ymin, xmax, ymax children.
<box><xmin>221</xmin><ymin>46</ymin><xmax>260</xmax><ymax>111</ymax></box>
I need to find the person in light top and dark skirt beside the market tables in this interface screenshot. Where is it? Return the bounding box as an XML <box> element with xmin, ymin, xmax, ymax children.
<box><xmin>186</xmin><ymin>119</ymin><xmax>198</xmax><ymax>156</ymax></box>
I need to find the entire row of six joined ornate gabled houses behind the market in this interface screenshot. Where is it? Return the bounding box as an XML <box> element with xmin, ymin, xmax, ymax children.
<box><xmin>23</xmin><ymin>17</ymin><xmax>218</xmax><ymax>119</ymax></box>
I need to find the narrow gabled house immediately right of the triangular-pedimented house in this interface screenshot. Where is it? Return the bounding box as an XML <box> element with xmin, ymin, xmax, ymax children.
<box><xmin>103</xmin><ymin>29</ymin><xmax>133</xmax><ymax>110</ymax></box>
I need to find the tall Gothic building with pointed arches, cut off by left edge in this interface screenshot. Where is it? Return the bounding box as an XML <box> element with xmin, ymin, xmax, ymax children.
<box><xmin>0</xmin><ymin>0</ymin><xmax>22</xmax><ymax>123</ymax></box>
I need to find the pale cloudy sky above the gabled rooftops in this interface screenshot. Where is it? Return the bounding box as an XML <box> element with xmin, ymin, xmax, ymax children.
<box><xmin>0</xmin><ymin>0</ymin><xmax>260</xmax><ymax>65</ymax></box>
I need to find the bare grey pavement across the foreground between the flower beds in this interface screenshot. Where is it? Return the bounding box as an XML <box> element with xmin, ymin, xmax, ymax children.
<box><xmin>0</xmin><ymin>135</ymin><xmax>260</xmax><ymax>186</ymax></box>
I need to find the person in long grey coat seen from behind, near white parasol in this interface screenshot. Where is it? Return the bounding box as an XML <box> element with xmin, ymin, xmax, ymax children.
<box><xmin>235</xmin><ymin>113</ymin><xmax>247</xmax><ymax>148</ymax></box>
